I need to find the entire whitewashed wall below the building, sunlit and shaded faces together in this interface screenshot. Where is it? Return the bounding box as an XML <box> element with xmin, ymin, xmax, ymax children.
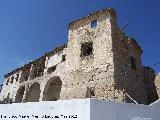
<box><xmin>0</xmin><ymin>99</ymin><xmax>160</xmax><ymax>120</ymax></box>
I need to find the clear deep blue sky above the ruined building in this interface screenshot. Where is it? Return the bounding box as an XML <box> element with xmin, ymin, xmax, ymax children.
<box><xmin>0</xmin><ymin>0</ymin><xmax>160</xmax><ymax>83</ymax></box>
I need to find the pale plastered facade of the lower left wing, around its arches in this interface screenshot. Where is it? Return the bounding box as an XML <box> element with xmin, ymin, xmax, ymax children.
<box><xmin>1</xmin><ymin>47</ymin><xmax>65</xmax><ymax>102</ymax></box>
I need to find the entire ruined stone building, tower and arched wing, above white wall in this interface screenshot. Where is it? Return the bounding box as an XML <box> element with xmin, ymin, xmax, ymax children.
<box><xmin>1</xmin><ymin>9</ymin><xmax>158</xmax><ymax>104</ymax></box>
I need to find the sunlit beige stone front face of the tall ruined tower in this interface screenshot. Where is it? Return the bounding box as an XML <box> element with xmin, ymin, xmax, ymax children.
<box><xmin>66</xmin><ymin>9</ymin><xmax>120</xmax><ymax>101</ymax></box>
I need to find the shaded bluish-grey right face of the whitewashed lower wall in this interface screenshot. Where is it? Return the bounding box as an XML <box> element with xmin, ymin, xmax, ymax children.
<box><xmin>90</xmin><ymin>100</ymin><xmax>160</xmax><ymax>120</ymax></box>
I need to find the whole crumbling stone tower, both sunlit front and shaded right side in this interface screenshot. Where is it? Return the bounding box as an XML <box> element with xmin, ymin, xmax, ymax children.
<box><xmin>66</xmin><ymin>9</ymin><xmax>153</xmax><ymax>104</ymax></box>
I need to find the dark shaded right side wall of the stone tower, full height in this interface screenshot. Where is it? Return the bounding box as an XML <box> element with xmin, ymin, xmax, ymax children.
<box><xmin>111</xmin><ymin>12</ymin><xmax>147</xmax><ymax>104</ymax></box>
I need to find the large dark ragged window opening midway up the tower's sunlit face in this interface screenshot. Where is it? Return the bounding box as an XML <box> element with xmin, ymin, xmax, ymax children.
<box><xmin>81</xmin><ymin>42</ymin><xmax>93</xmax><ymax>57</ymax></box>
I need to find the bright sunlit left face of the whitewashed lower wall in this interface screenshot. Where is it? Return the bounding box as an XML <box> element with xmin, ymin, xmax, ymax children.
<box><xmin>0</xmin><ymin>99</ymin><xmax>90</xmax><ymax>120</ymax></box>
